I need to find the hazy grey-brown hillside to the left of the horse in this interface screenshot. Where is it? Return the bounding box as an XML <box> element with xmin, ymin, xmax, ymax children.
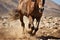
<box><xmin>0</xmin><ymin>0</ymin><xmax>18</xmax><ymax>16</ymax></box>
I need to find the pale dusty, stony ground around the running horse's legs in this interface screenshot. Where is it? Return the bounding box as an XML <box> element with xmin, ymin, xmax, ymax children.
<box><xmin>0</xmin><ymin>11</ymin><xmax>60</xmax><ymax>40</ymax></box>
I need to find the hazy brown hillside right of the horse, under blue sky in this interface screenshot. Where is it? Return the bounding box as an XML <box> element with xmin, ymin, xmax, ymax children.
<box><xmin>44</xmin><ymin>0</ymin><xmax>60</xmax><ymax>16</ymax></box>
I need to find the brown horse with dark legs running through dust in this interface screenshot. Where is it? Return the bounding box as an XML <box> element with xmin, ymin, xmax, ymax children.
<box><xmin>17</xmin><ymin>0</ymin><xmax>45</xmax><ymax>35</ymax></box>
